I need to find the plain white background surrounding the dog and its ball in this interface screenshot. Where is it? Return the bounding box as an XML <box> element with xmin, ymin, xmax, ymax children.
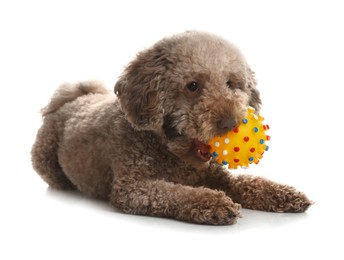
<box><xmin>0</xmin><ymin>0</ymin><xmax>344</xmax><ymax>259</ymax></box>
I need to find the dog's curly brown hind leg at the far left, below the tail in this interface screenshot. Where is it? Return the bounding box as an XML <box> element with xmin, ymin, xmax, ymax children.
<box><xmin>31</xmin><ymin>122</ymin><xmax>76</xmax><ymax>189</ymax></box>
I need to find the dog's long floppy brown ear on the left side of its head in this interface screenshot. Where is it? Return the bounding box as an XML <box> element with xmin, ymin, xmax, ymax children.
<box><xmin>115</xmin><ymin>47</ymin><xmax>166</xmax><ymax>131</ymax></box>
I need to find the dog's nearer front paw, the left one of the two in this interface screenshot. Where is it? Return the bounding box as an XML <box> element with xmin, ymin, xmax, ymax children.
<box><xmin>191</xmin><ymin>192</ymin><xmax>241</xmax><ymax>225</ymax></box>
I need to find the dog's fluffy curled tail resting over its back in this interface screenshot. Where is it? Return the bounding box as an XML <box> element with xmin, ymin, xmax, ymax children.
<box><xmin>42</xmin><ymin>81</ymin><xmax>109</xmax><ymax>116</ymax></box>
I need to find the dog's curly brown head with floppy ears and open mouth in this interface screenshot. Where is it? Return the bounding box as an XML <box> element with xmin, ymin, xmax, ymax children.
<box><xmin>115</xmin><ymin>31</ymin><xmax>261</xmax><ymax>168</ymax></box>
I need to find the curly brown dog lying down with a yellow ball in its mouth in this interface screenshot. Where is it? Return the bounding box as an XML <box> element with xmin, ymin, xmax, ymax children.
<box><xmin>32</xmin><ymin>32</ymin><xmax>312</xmax><ymax>224</ymax></box>
